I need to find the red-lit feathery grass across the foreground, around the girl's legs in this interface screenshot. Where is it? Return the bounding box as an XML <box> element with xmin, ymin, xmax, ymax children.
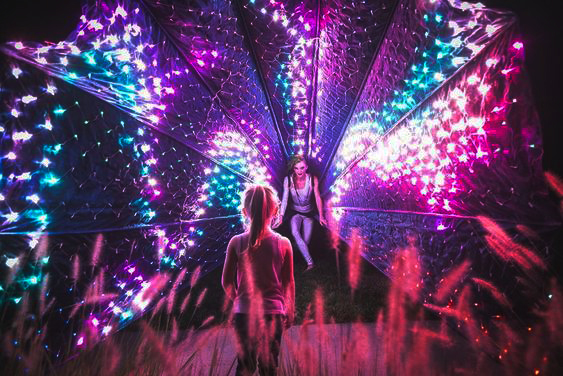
<box><xmin>1</xmin><ymin>181</ymin><xmax>563</xmax><ymax>376</ymax></box>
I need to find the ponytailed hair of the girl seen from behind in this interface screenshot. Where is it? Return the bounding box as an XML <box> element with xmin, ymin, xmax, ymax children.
<box><xmin>242</xmin><ymin>185</ymin><xmax>278</xmax><ymax>249</ymax></box>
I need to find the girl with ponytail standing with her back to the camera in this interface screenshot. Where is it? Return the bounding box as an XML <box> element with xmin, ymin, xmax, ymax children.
<box><xmin>221</xmin><ymin>185</ymin><xmax>295</xmax><ymax>375</ymax></box>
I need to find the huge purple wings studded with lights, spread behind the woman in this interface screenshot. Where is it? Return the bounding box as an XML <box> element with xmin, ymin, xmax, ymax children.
<box><xmin>0</xmin><ymin>0</ymin><xmax>557</xmax><ymax>347</ymax></box>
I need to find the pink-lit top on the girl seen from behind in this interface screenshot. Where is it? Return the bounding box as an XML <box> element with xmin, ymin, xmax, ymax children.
<box><xmin>233</xmin><ymin>233</ymin><xmax>287</xmax><ymax>315</ymax></box>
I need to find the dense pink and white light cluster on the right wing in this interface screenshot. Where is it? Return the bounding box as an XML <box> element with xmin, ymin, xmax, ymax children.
<box><xmin>332</xmin><ymin>35</ymin><xmax>528</xmax><ymax>212</ymax></box>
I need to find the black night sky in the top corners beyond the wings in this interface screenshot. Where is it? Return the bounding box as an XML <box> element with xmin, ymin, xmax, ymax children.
<box><xmin>0</xmin><ymin>0</ymin><xmax>563</xmax><ymax>176</ymax></box>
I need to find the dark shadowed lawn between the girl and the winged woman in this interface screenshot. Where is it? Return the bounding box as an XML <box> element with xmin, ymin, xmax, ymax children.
<box><xmin>182</xmin><ymin>222</ymin><xmax>390</xmax><ymax>328</ymax></box>
